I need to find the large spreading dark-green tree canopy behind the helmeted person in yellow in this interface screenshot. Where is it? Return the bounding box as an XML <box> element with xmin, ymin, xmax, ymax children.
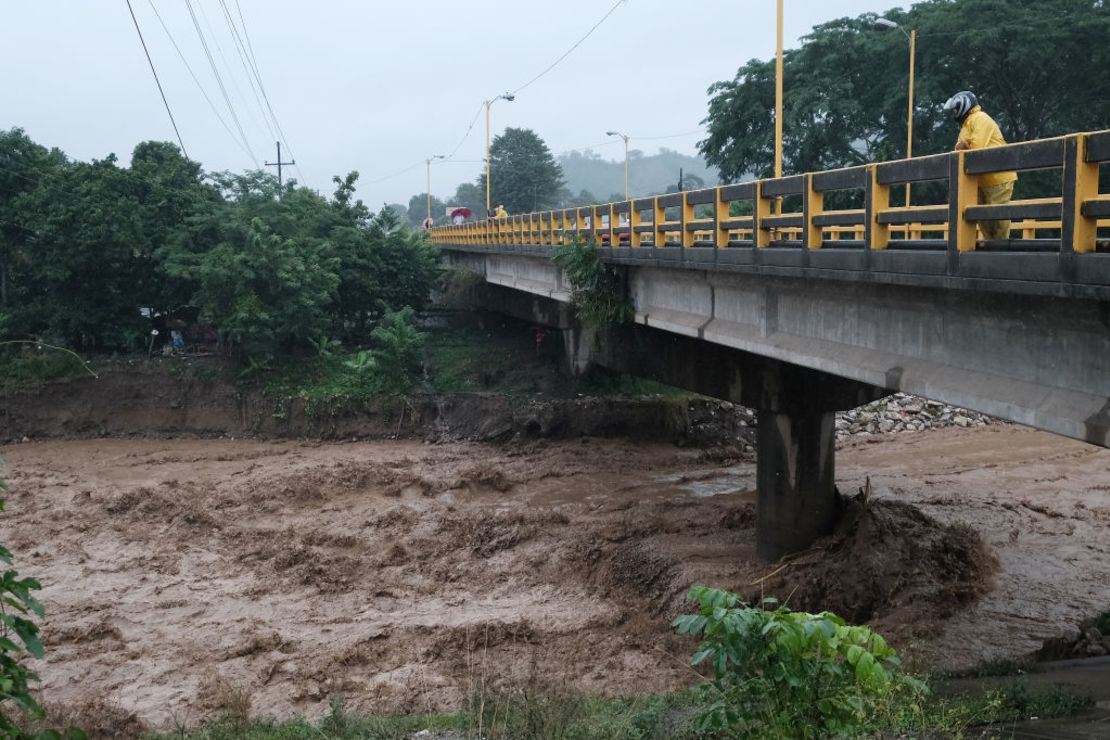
<box><xmin>699</xmin><ymin>0</ymin><xmax>1110</xmax><ymax>181</ymax></box>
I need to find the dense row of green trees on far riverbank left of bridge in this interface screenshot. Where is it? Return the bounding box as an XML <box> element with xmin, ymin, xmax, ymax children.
<box><xmin>0</xmin><ymin>129</ymin><xmax>437</xmax><ymax>355</ymax></box>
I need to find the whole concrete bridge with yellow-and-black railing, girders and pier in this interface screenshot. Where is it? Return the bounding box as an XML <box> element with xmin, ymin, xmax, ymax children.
<box><xmin>432</xmin><ymin>132</ymin><xmax>1110</xmax><ymax>559</ymax></box>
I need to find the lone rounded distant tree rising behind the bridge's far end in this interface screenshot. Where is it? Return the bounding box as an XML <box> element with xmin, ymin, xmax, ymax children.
<box><xmin>477</xmin><ymin>128</ymin><xmax>563</xmax><ymax>215</ymax></box>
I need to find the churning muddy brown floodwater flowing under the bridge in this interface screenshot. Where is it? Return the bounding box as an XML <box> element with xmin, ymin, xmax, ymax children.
<box><xmin>0</xmin><ymin>426</ymin><xmax>1110</xmax><ymax>728</ymax></box>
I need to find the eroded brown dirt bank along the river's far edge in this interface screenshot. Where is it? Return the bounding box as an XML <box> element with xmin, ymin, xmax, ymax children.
<box><xmin>0</xmin><ymin>365</ymin><xmax>751</xmax><ymax>446</ymax></box>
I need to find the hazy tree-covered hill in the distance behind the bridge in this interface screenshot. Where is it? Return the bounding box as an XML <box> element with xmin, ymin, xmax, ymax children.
<box><xmin>557</xmin><ymin>149</ymin><xmax>717</xmax><ymax>201</ymax></box>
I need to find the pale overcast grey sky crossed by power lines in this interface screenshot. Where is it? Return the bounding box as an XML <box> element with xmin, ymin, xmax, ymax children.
<box><xmin>0</xmin><ymin>0</ymin><xmax>899</xmax><ymax>207</ymax></box>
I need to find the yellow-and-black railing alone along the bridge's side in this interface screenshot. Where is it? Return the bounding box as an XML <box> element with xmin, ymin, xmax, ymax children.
<box><xmin>428</xmin><ymin>130</ymin><xmax>1110</xmax><ymax>254</ymax></box>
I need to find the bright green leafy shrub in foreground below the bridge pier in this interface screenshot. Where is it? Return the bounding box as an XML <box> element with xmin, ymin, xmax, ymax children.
<box><xmin>674</xmin><ymin>586</ymin><xmax>927</xmax><ymax>738</ymax></box>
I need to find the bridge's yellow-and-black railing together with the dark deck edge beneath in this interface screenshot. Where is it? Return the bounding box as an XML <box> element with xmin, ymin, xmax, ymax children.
<box><xmin>431</xmin><ymin>131</ymin><xmax>1110</xmax><ymax>300</ymax></box>
